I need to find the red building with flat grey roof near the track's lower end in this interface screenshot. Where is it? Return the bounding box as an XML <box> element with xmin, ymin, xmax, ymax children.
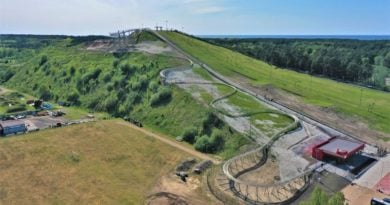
<box><xmin>312</xmin><ymin>137</ymin><xmax>364</xmax><ymax>160</ymax></box>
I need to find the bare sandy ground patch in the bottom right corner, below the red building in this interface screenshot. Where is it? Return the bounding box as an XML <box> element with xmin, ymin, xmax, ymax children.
<box><xmin>342</xmin><ymin>185</ymin><xmax>388</xmax><ymax>205</ymax></box>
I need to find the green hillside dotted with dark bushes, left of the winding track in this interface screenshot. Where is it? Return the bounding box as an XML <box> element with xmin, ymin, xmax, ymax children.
<box><xmin>0</xmin><ymin>33</ymin><xmax>247</xmax><ymax>157</ymax></box>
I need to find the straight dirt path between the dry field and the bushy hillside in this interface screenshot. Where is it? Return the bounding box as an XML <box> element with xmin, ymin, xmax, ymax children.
<box><xmin>118</xmin><ymin>122</ymin><xmax>221</xmax><ymax>164</ymax></box>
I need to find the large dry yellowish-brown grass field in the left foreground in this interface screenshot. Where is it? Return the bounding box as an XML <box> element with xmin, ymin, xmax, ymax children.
<box><xmin>0</xmin><ymin>120</ymin><xmax>192</xmax><ymax>204</ymax></box>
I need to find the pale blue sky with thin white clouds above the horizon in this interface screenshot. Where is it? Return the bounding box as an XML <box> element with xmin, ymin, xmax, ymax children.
<box><xmin>0</xmin><ymin>0</ymin><xmax>390</xmax><ymax>35</ymax></box>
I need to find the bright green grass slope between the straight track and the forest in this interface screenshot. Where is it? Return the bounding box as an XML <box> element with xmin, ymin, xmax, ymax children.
<box><xmin>161</xmin><ymin>32</ymin><xmax>390</xmax><ymax>133</ymax></box>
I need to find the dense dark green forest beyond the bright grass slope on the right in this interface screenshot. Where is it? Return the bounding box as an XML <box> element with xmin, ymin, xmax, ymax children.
<box><xmin>206</xmin><ymin>39</ymin><xmax>390</xmax><ymax>91</ymax></box>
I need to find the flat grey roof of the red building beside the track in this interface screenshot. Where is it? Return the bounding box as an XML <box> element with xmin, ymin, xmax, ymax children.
<box><xmin>318</xmin><ymin>138</ymin><xmax>364</xmax><ymax>159</ymax></box>
